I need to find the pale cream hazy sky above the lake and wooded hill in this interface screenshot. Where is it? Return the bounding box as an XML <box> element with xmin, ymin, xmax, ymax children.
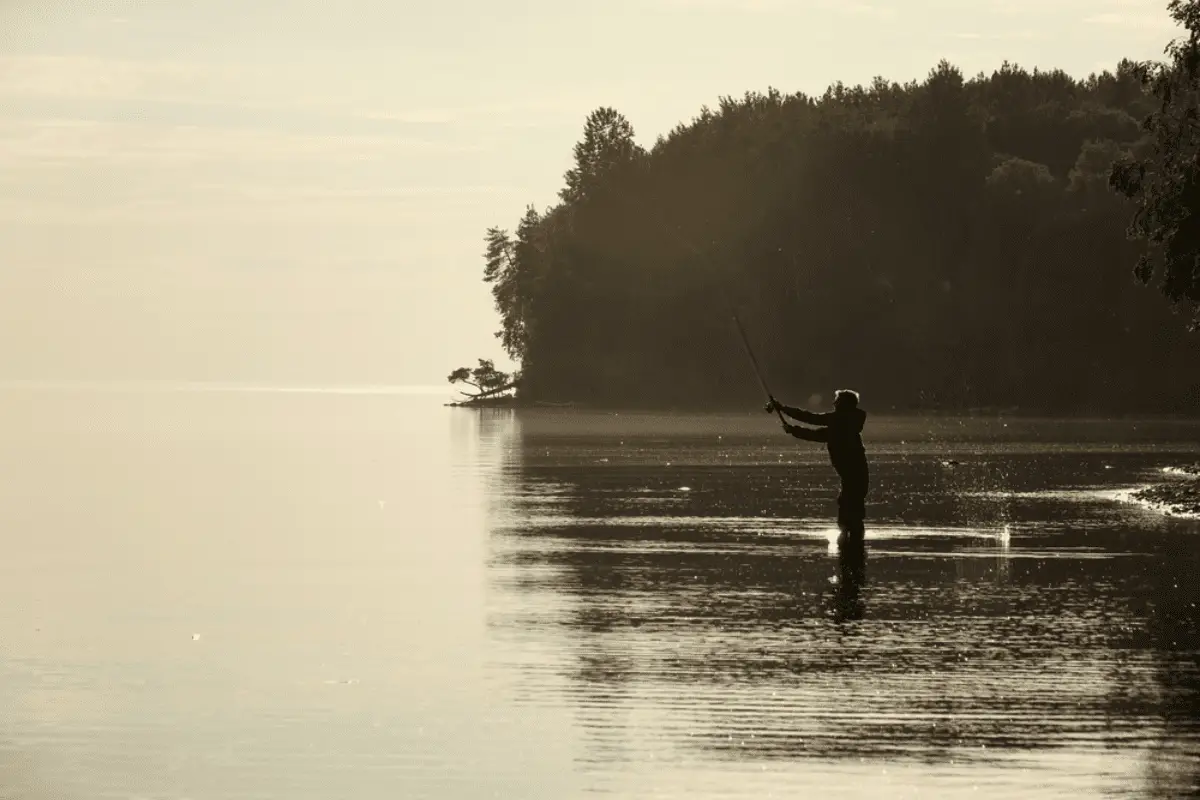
<box><xmin>0</xmin><ymin>0</ymin><xmax>1174</xmax><ymax>384</ymax></box>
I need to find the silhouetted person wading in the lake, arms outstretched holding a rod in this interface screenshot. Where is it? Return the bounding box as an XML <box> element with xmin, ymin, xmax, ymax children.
<box><xmin>767</xmin><ymin>389</ymin><xmax>870</xmax><ymax>541</ymax></box>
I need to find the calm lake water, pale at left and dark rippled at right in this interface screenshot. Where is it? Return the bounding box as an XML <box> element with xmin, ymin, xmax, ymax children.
<box><xmin>0</xmin><ymin>386</ymin><xmax>1200</xmax><ymax>800</ymax></box>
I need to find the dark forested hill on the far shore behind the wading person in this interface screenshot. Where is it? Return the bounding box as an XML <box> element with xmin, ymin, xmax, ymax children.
<box><xmin>465</xmin><ymin>61</ymin><xmax>1200</xmax><ymax>413</ymax></box>
